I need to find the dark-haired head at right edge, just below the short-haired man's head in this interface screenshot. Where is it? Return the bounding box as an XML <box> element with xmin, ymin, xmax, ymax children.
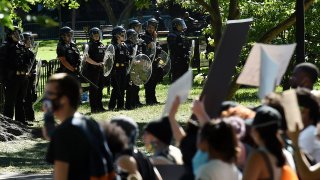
<box><xmin>296</xmin><ymin>88</ymin><xmax>319</xmax><ymax>127</ymax></box>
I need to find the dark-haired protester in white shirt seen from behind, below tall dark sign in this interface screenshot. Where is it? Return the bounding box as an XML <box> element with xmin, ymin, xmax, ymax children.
<box><xmin>196</xmin><ymin>120</ymin><xmax>242</xmax><ymax>180</ymax></box>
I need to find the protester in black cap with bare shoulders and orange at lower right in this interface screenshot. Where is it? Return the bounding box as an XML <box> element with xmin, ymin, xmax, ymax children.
<box><xmin>243</xmin><ymin>105</ymin><xmax>298</xmax><ymax>180</ymax></box>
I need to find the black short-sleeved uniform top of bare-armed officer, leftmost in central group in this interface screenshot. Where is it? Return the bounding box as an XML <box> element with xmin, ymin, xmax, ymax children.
<box><xmin>57</xmin><ymin>41</ymin><xmax>80</xmax><ymax>75</ymax></box>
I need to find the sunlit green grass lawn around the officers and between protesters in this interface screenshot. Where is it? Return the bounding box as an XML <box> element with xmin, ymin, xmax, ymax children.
<box><xmin>0</xmin><ymin>41</ymin><xmax>270</xmax><ymax>175</ymax></box>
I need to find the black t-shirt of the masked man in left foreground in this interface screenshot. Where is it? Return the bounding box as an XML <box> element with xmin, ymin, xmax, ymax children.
<box><xmin>46</xmin><ymin>117</ymin><xmax>90</xmax><ymax>180</ymax></box>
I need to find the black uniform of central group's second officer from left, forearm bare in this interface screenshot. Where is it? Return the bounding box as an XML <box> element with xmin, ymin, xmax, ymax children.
<box><xmin>83</xmin><ymin>41</ymin><xmax>105</xmax><ymax>112</ymax></box>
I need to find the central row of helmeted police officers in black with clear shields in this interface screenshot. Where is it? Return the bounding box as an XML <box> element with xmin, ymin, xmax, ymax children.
<box><xmin>50</xmin><ymin>18</ymin><xmax>190</xmax><ymax>113</ymax></box>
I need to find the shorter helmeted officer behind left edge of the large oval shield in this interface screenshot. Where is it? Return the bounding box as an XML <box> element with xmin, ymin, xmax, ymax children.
<box><xmin>125</xmin><ymin>29</ymin><xmax>142</xmax><ymax>109</ymax></box>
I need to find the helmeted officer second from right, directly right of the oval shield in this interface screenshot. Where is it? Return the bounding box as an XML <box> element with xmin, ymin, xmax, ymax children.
<box><xmin>141</xmin><ymin>18</ymin><xmax>163</xmax><ymax>105</ymax></box>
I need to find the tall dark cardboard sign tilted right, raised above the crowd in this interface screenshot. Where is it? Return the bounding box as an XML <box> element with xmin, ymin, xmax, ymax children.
<box><xmin>200</xmin><ymin>19</ymin><xmax>252</xmax><ymax>118</ymax></box>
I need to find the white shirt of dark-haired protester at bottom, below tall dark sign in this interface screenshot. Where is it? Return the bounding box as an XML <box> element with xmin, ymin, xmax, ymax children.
<box><xmin>196</xmin><ymin>159</ymin><xmax>242</xmax><ymax>180</ymax></box>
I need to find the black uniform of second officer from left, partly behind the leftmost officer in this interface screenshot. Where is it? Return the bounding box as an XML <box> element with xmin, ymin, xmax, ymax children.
<box><xmin>24</xmin><ymin>49</ymin><xmax>37</xmax><ymax>121</ymax></box>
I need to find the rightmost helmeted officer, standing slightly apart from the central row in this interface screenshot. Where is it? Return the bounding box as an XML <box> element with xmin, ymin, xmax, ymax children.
<box><xmin>167</xmin><ymin>18</ymin><xmax>190</xmax><ymax>82</ymax></box>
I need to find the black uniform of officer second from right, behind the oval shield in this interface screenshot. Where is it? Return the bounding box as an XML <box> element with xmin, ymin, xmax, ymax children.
<box><xmin>141</xmin><ymin>32</ymin><xmax>163</xmax><ymax>104</ymax></box>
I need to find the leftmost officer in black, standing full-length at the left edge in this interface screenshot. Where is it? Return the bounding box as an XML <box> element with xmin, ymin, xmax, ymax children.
<box><xmin>0</xmin><ymin>27</ymin><xmax>31</xmax><ymax>124</ymax></box>
